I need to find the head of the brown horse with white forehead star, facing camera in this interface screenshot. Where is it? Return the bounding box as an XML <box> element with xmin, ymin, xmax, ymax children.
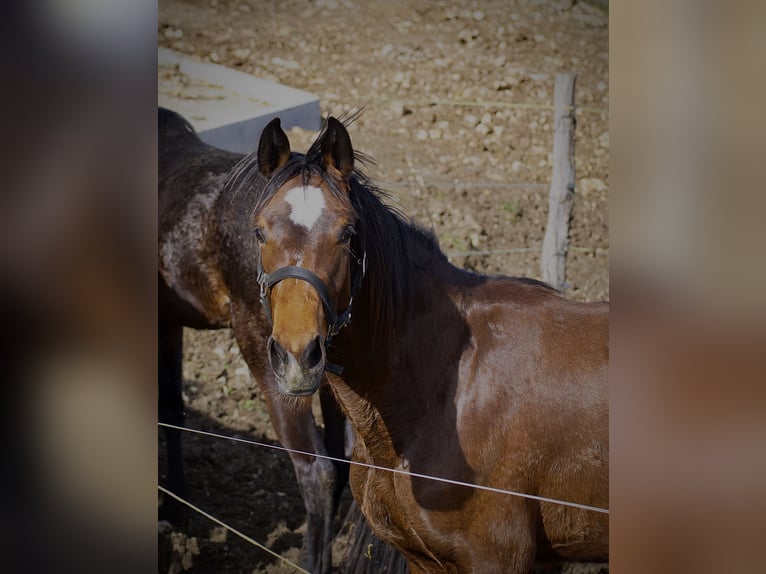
<box><xmin>255</xmin><ymin>117</ymin><xmax>364</xmax><ymax>395</ymax></box>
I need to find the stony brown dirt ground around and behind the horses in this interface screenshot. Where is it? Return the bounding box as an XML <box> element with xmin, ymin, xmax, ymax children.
<box><xmin>158</xmin><ymin>0</ymin><xmax>609</xmax><ymax>574</ymax></box>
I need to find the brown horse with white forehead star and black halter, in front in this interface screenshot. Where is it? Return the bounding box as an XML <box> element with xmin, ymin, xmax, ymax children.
<box><xmin>242</xmin><ymin>118</ymin><xmax>609</xmax><ymax>573</ymax></box>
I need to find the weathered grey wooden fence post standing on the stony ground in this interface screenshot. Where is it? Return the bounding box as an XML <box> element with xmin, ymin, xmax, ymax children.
<box><xmin>540</xmin><ymin>72</ymin><xmax>577</xmax><ymax>290</ymax></box>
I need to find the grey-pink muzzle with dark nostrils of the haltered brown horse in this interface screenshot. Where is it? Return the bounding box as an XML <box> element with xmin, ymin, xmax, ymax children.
<box><xmin>267</xmin><ymin>335</ymin><xmax>325</xmax><ymax>396</ymax></box>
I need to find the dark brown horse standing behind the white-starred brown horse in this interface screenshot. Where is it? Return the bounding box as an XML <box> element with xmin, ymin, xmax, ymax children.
<box><xmin>158</xmin><ymin>109</ymin><xmax>404</xmax><ymax>573</ymax></box>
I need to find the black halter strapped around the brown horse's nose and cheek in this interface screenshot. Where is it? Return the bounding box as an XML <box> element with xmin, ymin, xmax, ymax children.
<box><xmin>256</xmin><ymin>252</ymin><xmax>367</xmax><ymax>375</ymax></box>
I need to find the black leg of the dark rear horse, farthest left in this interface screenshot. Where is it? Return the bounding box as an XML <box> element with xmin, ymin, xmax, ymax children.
<box><xmin>157</xmin><ymin>322</ymin><xmax>186</xmax><ymax>519</ymax></box>
